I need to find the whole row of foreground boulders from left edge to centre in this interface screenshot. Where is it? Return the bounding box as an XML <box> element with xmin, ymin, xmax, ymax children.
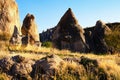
<box><xmin>0</xmin><ymin>55</ymin><xmax>64</xmax><ymax>80</ymax></box>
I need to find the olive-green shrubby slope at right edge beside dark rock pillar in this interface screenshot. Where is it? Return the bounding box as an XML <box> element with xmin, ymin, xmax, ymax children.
<box><xmin>105</xmin><ymin>23</ymin><xmax>120</xmax><ymax>52</ymax></box>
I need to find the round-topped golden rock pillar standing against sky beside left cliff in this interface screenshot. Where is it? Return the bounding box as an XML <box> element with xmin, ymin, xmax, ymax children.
<box><xmin>21</xmin><ymin>14</ymin><xmax>39</xmax><ymax>45</ymax></box>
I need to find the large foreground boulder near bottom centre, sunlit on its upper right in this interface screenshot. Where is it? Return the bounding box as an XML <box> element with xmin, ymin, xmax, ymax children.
<box><xmin>35</xmin><ymin>55</ymin><xmax>64</xmax><ymax>80</ymax></box>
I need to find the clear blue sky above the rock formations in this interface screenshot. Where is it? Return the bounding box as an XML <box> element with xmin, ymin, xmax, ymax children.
<box><xmin>16</xmin><ymin>0</ymin><xmax>120</xmax><ymax>32</ymax></box>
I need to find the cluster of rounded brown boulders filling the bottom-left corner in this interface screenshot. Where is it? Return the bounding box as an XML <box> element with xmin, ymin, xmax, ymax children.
<box><xmin>0</xmin><ymin>55</ymin><xmax>35</xmax><ymax>80</ymax></box>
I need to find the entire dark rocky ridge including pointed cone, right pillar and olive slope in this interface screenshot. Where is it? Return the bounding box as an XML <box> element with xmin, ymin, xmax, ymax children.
<box><xmin>40</xmin><ymin>9</ymin><xmax>120</xmax><ymax>54</ymax></box>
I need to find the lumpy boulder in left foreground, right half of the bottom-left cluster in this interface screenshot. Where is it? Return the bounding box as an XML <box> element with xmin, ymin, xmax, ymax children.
<box><xmin>11</xmin><ymin>55</ymin><xmax>35</xmax><ymax>80</ymax></box>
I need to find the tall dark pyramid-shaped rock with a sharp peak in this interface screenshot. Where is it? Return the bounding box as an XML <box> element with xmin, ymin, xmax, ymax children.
<box><xmin>52</xmin><ymin>8</ymin><xmax>87</xmax><ymax>52</ymax></box>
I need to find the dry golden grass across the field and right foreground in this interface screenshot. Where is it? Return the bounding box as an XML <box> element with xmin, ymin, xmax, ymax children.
<box><xmin>0</xmin><ymin>42</ymin><xmax>120</xmax><ymax>80</ymax></box>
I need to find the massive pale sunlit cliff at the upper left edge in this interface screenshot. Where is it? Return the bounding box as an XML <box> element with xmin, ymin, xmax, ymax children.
<box><xmin>0</xmin><ymin>0</ymin><xmax>20</xmax><ymax>39</ymax></box>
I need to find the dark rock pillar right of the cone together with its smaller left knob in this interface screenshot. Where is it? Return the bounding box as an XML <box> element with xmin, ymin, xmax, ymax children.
<box><xmin>86</xmin><ymin>20</ymin><xmax>111</xmax><ymax>53</ymax></box>
